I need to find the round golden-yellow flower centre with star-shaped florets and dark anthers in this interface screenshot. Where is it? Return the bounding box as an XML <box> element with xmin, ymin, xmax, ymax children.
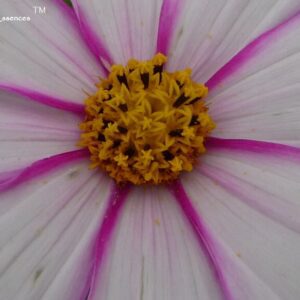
<box><xmin>79</xmin><ymin>53</ymin><xmax>215</xmax><ymax>185</ymax></box>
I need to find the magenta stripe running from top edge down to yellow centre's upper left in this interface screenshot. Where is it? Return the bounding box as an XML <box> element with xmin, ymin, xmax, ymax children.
<box><xmin>73</xmin><ymin>0</ymin><xmax>113</xmax><ymax>74</ymax></box>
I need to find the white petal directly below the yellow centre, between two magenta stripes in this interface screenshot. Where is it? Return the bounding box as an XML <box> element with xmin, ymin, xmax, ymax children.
<box><xmin>90</xmin><ymin>187</ymin><xmax>221</xmax><ymax>300</ymax></box>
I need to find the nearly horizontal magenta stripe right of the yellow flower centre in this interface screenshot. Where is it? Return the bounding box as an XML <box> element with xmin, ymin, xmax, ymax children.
<box><xmin>205</xmin><ymin>137</ymin><xmax>300</xmax><ymax>160</ymax></box>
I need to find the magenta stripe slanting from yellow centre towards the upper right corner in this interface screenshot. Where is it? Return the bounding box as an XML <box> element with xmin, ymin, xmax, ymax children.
<box><xmin>206</xmin><ymin>12</ymin><xmax>300</xmax><ymax>90</ymax></box>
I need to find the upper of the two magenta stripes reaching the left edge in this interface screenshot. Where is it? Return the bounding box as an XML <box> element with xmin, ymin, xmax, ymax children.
<box><xmin>0</xmin><ymin>84</ymin><xmax>84</xmax><ymax>115</ymax></box>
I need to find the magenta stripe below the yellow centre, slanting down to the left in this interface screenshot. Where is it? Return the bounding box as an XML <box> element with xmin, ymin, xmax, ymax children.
<box><xmin>83</xmin><ymin>184</ymin><xmax>130</xmax><ymax>299</ymax></box>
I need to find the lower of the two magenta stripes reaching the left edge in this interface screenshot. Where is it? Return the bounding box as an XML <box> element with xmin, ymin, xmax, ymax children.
<box><xmin>0</xmin><ymin>149</ymin><xmax>89</xmax><ymax>192</ymax></box>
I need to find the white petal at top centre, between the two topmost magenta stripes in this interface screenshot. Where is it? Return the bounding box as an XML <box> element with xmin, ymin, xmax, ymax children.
<box><xmin>72</xmin><ymin>0</ymin><xmax>162</xmax><ymax>64</ymax></box>
